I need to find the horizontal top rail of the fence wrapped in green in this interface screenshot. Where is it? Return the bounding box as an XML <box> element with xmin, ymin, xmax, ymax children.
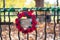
<box><xmin>0</xmin><ymin>7</ymin><xmax>60</xmax><ymax>12</ymax></box>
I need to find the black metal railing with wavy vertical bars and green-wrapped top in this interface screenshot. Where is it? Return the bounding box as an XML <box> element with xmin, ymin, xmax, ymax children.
<box><xmin>0</xmin><ymin>0</ymin><xmax>60</xmax><ymax>40</ymax></box>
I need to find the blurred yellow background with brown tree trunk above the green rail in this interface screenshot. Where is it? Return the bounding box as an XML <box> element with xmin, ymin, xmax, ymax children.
<box><xmin>0</xmin><ymin>0</ymin><xmax>60</xmax><ymax>8</ymax></box>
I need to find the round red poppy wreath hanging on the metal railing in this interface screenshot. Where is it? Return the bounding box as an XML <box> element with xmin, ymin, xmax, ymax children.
<box><xmin>15</xmin><ymin>11</ymin><xmax>37</xmax><ymax>34</ymax></box>
